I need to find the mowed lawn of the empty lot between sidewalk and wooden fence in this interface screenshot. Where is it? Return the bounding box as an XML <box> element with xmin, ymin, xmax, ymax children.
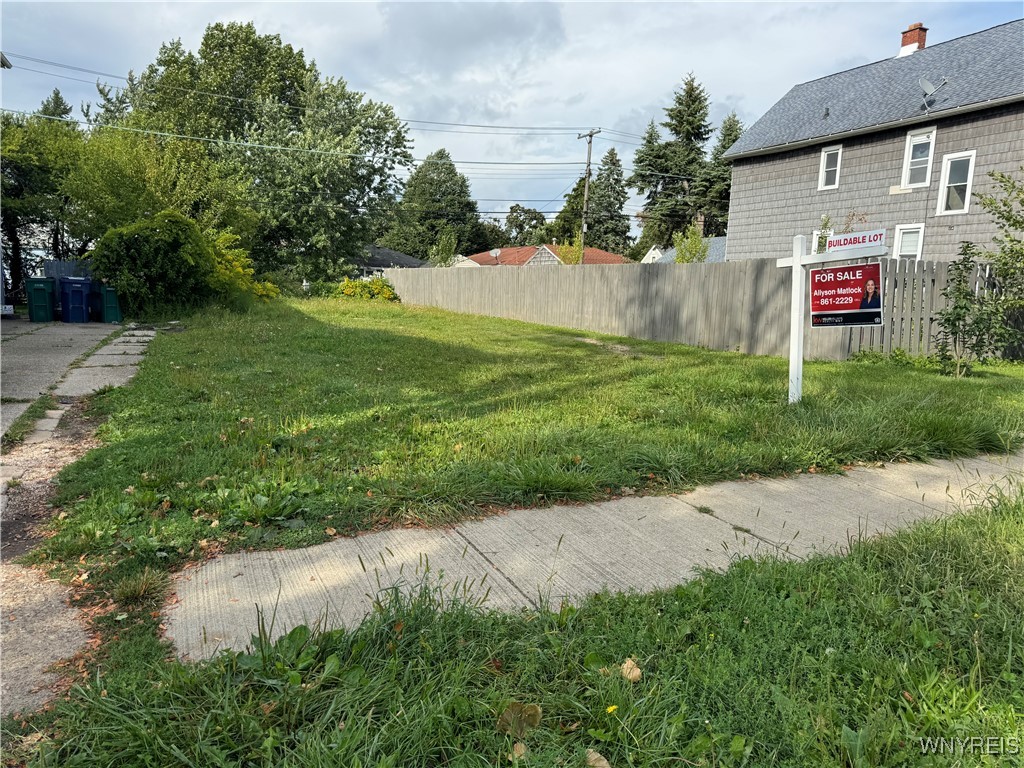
<box><xmin>49</xmin><ymin>299</ymin><xmax>1024</xmax><ymax>556</ymax></box>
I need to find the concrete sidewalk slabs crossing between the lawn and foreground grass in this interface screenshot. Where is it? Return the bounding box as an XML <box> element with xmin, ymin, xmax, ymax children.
<box><xmin>168</xmin><ymin>454</ymin><xmax>1024</xmax><ymax>658</ymax></box>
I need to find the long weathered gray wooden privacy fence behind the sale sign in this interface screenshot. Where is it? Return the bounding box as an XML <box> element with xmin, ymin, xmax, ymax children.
<box><xmin>385</xmin><ymin>259</ymin><xmax>984</xmax><ymax>359</ymax></box>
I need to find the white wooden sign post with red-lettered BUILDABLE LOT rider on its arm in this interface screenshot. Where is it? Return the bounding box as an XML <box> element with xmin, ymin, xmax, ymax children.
<box><xmin>775</xmin><ymin>229</ymin><xmax>889</xmax><ymax>403</ymax></box>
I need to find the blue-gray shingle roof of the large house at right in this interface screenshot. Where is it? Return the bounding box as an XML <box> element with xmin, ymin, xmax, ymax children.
<box><xmin>725</xmin><ymin>19</ymin><xmax>1024</xmax><ymax>160</ymax></box>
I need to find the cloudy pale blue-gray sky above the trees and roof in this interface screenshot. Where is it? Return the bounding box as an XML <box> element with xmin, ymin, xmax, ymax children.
<box><xmin>0</xmin><ymin>0</ymin><xmax>1021</xmax><ymax>224</ymax></box>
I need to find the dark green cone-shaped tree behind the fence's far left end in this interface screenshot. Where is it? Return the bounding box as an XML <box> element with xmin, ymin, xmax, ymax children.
<box><xmin>381</xmin><ymin>150</ymin><xmax>486</xmax><ymax>259</ymax></box>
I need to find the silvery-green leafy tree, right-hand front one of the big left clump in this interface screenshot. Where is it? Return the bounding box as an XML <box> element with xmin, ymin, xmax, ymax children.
<box><xmin>222</xmin><ymin>73</ymin><xmax>409</xmax><ymax>280</ymax></box>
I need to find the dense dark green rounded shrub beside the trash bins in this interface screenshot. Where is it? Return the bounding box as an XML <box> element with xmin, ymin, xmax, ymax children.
<box><xmin>89</xmin><ymin>211</ymin><xmax>216</xmax><ymax>315</ymax></box>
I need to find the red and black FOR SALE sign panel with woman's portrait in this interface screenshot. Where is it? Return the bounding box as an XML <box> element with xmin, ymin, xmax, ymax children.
<box><xmin>811</xmin><ymin>263</ymin><xmax>882</xmax><ymax>328</ymax></box>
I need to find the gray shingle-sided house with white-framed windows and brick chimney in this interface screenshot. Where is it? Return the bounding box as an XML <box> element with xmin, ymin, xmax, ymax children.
<box><xmin>726</xmin><ymin>20</ymin><xmax>1024</xmax><ymax>261</ymax></box>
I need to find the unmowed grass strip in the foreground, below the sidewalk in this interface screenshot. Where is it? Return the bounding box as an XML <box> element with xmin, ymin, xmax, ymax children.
<box><xmin>16</xmin><ymin>489</ymin><xmax>1024</xmax><ymax>768</ymax></box>
